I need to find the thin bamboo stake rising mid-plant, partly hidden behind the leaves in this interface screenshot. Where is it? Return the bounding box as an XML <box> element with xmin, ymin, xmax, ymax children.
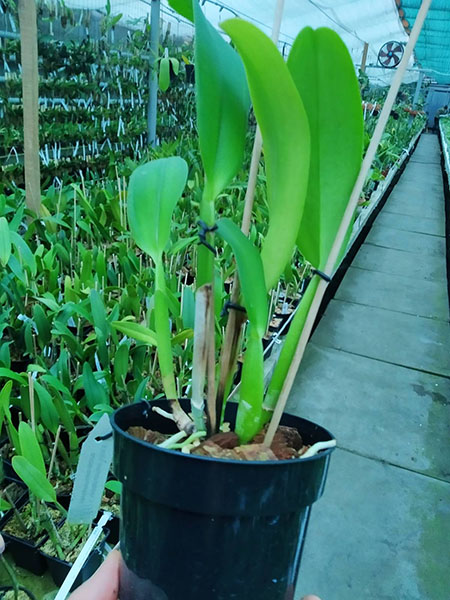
<box><xmin>216</xmin><ymin>0</ymin><xmax>284</xmax><ymax>424</ymax></box>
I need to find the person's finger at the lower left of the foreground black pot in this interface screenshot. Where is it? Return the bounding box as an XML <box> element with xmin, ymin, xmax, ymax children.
<box><xmin>69</xmin><ymin>550</ymin><xmax>120</xmax><ymax>600</ymax></box>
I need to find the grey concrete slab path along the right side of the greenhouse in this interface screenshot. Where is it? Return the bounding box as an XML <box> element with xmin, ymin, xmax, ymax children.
<box><xmin>289</xmin><ymin>134</ymin><xmax>450</xmax><ymax>600</ymax></box>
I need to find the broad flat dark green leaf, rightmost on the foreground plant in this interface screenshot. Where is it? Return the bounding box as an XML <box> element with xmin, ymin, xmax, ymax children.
<box><xmin>287</xmin><ymin>27</ymin><xmax>364</xmax><ymax>269</ymax></box>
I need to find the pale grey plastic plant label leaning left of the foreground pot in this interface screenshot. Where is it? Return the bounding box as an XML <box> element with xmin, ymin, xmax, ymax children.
<box><xmin>67</xmin><ymin>414</ymin><xmax>113</xmax><ymax>524</ymax></box>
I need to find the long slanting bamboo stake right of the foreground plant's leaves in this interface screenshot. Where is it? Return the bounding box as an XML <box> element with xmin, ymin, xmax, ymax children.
<box><xmin>264</xmin><ymin>0</ymin><xmax>432</xmax><ymax>446</ymax></box>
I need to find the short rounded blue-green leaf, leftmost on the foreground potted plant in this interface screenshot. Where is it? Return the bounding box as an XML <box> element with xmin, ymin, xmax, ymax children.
<box><xmin>127</xmin><ymin>156</ymin><xmax>188</xmax><ymax>261</ymax></box>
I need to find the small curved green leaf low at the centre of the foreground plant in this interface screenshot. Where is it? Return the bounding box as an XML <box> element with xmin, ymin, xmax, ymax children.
<box><xmin>217</xmin><ymin>219</ymin><xmax>268</xmax><ymax>337</ymax></box>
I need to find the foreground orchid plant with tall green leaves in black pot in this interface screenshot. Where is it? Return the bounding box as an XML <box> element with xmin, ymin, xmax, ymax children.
<box><xmin>112</xmin><ymin>0</ymin><xmax>363</xmax><ymax>600</ymax></box>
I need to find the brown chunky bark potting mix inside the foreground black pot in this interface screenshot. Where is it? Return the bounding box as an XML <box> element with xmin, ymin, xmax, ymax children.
<box><xmin>127</xmin><ymin>425</ymin><xmax>309</xmax><ymax>461</ymax></box>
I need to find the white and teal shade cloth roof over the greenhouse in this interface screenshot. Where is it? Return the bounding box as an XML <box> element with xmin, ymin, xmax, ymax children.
<box><xmin>65</xmin><ymin>0</ymin><xmax>450</xmax><ymax>85</ymax></box>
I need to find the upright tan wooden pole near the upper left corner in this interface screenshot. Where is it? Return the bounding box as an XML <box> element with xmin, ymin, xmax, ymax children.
<box><xmin>19</xmin><ymin>0</ymin><xmax>41</xmax><ymax>215</ymax></box>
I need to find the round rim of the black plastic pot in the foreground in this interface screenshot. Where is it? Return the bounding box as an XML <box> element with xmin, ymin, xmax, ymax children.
<box><xmin>111</xmin><ymin>401</ymin><xmax>335</xmax><ymax>468</ymax></box>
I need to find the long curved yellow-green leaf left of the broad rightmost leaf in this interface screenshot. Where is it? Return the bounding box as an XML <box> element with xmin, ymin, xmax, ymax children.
<box><xmin>222</xmin><ymin>19</ymin><xmax>310</xmax><ymax>289</ymax></box>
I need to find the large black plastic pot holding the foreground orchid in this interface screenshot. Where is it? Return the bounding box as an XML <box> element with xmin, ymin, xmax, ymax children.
<box><xmin>112</xmin><ymin>401</ymin><xmax>332</xmax><ymax>600</ymax></box>
